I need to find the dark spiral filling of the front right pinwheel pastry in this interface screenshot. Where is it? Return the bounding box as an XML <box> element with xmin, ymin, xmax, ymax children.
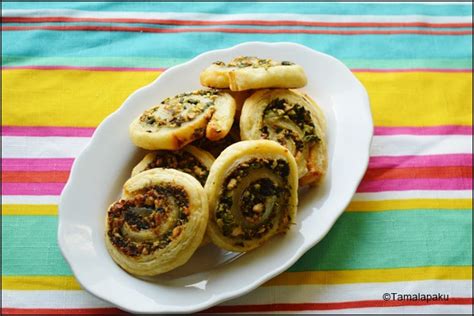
<box><xmin>215</xmin><ymin>158</ymin><xmax>291</xmax><ymax>240</ymax></box>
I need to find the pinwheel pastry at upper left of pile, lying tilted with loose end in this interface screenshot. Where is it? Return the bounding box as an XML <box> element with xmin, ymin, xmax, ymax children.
<box><xmin>129</xmin><ymin>89</ymin><xmax>235</xmax><ymax>150</ymax></box>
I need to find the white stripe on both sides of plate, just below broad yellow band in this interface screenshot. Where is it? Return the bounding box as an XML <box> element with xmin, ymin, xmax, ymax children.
<box><xmin>2</xmin><ymin>135</ymin><xmax>472</xmax><ymax>158</ymax></box>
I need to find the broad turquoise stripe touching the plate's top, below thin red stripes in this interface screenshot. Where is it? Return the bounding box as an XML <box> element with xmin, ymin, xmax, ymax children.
<box><xmin>2</xmin><ymin>31</ymin><xmax>472</xmax><ymax>59</ymax></box>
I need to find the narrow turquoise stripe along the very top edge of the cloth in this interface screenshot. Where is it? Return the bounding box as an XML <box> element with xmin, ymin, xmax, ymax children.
<box><xmin>2</xmin><ymin>2</ymin><xmax>472</xmax><ymax>16</ymax></box>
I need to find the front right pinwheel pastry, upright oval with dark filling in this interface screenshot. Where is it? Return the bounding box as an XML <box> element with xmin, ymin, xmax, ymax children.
<box><xmin>204</xmin><ymin>140</ymin><xmax>298</xmax><ymax>252</ymax></box>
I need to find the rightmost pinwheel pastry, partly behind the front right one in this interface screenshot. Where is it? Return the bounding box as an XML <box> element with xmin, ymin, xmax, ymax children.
<box><xmin>240</xmin><ymin>89</ymin><xmax>327</xmax><ymax>185</ymax></box>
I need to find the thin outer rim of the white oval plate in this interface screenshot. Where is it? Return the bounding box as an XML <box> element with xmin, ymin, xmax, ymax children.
<box><xmin>57</xmin><ymin>41</ymin><xmax>374</xmax><ymax>314</ymax></box>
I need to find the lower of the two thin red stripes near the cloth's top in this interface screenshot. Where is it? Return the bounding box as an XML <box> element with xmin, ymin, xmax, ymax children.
<box><xmin>2</xmin><ymin>25</ymin><xmax>472</xmax><ymax>35</ymax></box>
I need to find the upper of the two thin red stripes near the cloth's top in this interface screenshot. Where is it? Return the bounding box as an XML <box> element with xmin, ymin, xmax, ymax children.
<box><xmin>2</xmin><ymin>16</ymin><xmax>472</xmax><ymax>28</ymax></box>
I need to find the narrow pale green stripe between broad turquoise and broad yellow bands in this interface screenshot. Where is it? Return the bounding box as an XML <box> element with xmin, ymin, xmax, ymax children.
<box><xmin>2</xmin><ymin>56</ymin><xmax>472</xmax><ymax>69</ymax></box>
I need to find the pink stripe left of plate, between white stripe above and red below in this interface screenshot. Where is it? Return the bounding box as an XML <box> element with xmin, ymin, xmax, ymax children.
<box><xmin>2</xmin><ymin>158</ymin><xmax>74</xmax><ymax>171</ymax></box>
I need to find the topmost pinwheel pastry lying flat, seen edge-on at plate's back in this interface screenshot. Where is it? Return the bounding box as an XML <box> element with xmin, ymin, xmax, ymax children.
<box><xmin>200</xmin><ymin>56</ymin><xmax>307</xmax><ymax>91</ymax></box>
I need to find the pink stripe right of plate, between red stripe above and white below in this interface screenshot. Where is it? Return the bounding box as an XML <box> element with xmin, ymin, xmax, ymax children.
<box><xmin>357</xmin><ymin>178</ymin><xmax>472</xmax><ymax>192</ymax></box>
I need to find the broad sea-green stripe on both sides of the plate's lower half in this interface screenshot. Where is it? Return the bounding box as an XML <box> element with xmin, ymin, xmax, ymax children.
<box><xmin>2</xmin><ymin>210</ymin><xmax>472</xmax><ymax>275</ymax></box>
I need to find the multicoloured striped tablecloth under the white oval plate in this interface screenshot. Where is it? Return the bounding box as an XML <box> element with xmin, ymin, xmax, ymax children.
<box><xmin>2</xmin><ymin>2</ymin><xmax>472</xmax><ymax>314</ymax></box>
